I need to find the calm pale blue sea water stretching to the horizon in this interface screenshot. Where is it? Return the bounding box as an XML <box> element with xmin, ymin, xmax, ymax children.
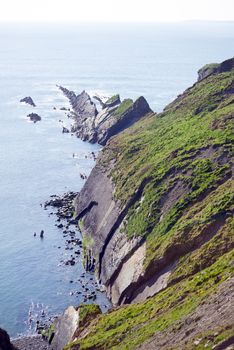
<box><xmin>0</xmin><ymin>23</ymin><xmax>234</xmax><ymax>336</ymax></box>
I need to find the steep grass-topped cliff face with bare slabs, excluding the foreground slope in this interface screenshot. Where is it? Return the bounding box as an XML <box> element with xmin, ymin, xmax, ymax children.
<box><xmin>76</xmin><ymin>59</ymin><xmax>233</xmax><ymax>305</ymax></box>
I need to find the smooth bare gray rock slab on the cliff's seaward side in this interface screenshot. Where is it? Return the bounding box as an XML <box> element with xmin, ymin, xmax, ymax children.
<box><xmin>75</xmin><ymin>160</ymin><xmax>149</xmax><ymax>305</ymax></box>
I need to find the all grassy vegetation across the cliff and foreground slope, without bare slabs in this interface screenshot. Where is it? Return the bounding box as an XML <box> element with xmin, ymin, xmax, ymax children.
<box><xmin>67</xmin><ymin>59</ymin><xmax>234</xmax><ymax>350</ymax></box>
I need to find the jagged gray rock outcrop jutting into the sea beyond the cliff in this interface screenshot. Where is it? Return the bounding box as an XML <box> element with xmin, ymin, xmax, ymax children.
<box><xmin>59</xmin><ymin>86</ymin><xmax>152</xmax><ymax>145</ymax></box>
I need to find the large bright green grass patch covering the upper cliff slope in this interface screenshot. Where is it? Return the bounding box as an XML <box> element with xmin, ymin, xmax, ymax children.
<box><xmin>102</xmin><ymin>71</ymin><xmax>234</xmax><ymax>270</ymax></box>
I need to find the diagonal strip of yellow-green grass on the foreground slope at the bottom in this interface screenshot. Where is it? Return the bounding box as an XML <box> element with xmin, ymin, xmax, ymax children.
<box><xmin>64</xmin><ymin>252</ymin><xmax>234</xmax><ymax>350</ymax></box>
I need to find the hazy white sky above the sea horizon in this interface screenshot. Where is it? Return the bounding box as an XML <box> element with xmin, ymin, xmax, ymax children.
<box><xmin>0</xmin><ymin>0</ymin><xmax>234</xmax><ymax>22</ymax></box>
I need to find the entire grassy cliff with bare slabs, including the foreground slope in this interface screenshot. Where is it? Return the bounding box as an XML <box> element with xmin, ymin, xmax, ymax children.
<box><xmin>64</xmin><ymin>58</ymin><xmax>234</xmax><ymax>349</ymax></box>
